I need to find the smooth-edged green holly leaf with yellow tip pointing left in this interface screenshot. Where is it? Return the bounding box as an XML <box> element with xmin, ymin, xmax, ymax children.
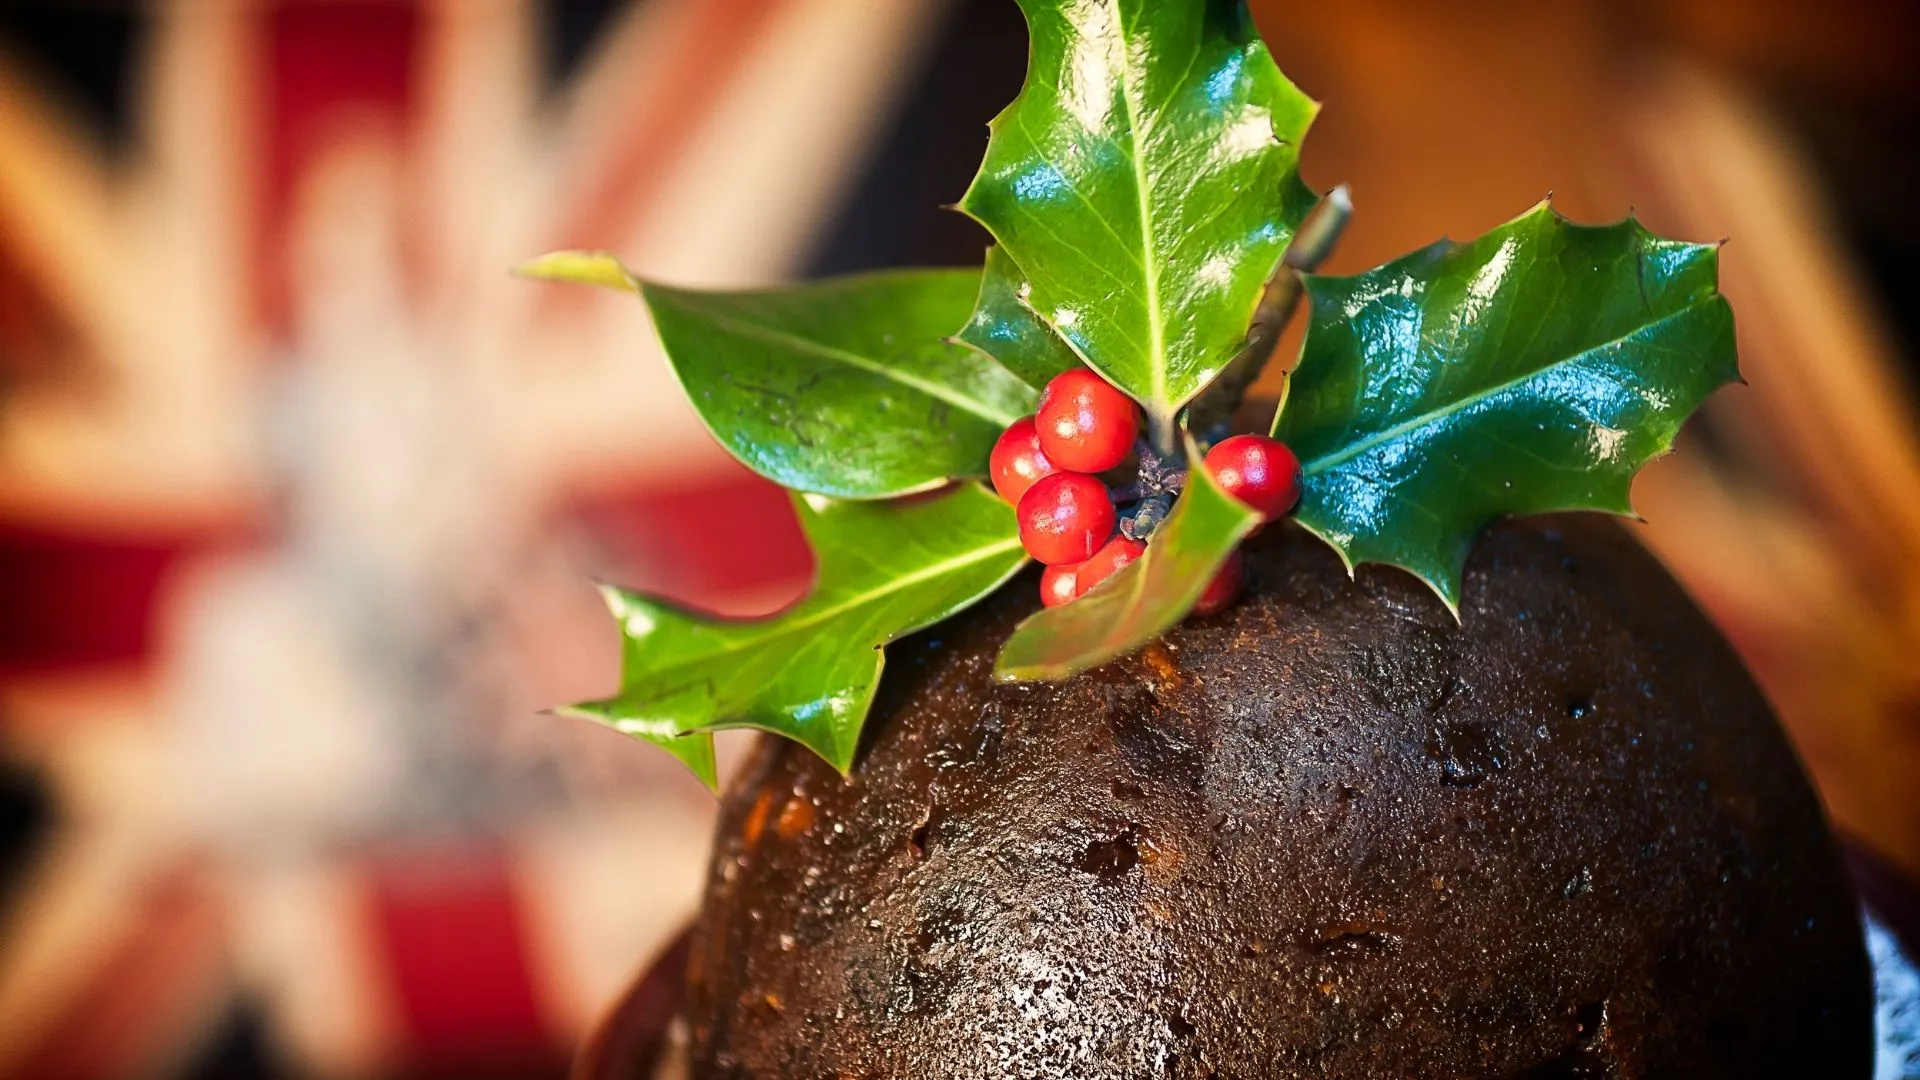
<box><xmin>520</xmin><ymin>252</ymin><xmax>1035</xmax><ymax>500</ymax></box>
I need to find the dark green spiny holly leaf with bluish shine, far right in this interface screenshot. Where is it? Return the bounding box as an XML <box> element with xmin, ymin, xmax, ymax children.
<box><xmin>1275</xmin><ymin>204</ymin><xmax>1740</xmax><ymax>609</ymax></box>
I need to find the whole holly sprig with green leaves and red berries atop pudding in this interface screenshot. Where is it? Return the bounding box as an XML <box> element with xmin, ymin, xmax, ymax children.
<box><xmin>518</xmin><ymin>0</ymin><xmax>1738</xmax><ymax>784</ymax></box>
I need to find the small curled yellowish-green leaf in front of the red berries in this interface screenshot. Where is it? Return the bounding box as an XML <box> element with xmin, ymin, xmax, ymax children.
<box><xmin>995</xmin><ymin>434</ymin><xmax>1260</xmax><ymax>682</ymax></box>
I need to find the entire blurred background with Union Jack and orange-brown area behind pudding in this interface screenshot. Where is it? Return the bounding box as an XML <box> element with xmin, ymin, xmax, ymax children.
<box><xmin>0</xmin><ymin>0</ymin><xmax>1920</xmax><ymax>1080</ymax></box>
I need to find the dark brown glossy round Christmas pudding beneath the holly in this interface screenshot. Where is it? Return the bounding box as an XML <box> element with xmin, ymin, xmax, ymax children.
<box><xmin>687</xmin><ymin>515</ymin><xmax>1872</xmax><ymax>1080</ymax></box>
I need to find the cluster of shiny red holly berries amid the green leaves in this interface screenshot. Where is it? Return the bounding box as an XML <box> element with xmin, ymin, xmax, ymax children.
<box><xmin>989</xmin><ymin>367</ymin><xmax>1300</xmax><ymax>615</ymax></box>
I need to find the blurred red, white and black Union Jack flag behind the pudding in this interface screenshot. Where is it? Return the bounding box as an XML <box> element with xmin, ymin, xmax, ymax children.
<box><xmin>0</xmin><ymin>0</ymin><xmax>1021</xmax><ymax>1078</ymax></box>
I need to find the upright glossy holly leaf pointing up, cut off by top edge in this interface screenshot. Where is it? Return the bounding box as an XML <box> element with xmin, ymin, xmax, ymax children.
<box><xmin>960</xmin><ymin>0</ymin><xmax>1317</xmax><ymax>430</ymax></box>
